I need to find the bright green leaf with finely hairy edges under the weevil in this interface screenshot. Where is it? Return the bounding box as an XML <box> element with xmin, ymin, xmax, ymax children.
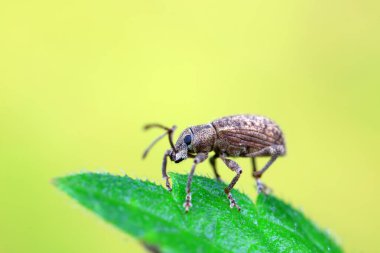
<box><xmin>55</xmin><ymin>173</ymin><xmax>342</xmax><ymax>253</ymax></box>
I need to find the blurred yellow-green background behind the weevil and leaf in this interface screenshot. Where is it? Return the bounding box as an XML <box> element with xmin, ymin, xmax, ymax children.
<box><xmin>0</xmin><ymin>0</ymin><xmax>380</xmax><ymax>253</ymax></box>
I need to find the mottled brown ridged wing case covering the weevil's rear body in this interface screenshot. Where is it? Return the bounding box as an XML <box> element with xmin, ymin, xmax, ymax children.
<box><xmin>211</xmin><ymin>115</ymin><xmax>284</xmax><ymax>153</ymax></box>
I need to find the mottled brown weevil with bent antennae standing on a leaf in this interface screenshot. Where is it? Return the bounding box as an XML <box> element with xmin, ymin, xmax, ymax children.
<box><xmin>143</xmin><ymin>114</ymin><xmax>286</xmax><ymax>212</ymax></box>
